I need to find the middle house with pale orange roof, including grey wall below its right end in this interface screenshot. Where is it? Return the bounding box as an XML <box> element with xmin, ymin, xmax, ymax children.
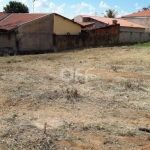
<box><xmin>74</xmin><ymin>15</ymin><xmax>150</xmax><ymax>43</ymax></box>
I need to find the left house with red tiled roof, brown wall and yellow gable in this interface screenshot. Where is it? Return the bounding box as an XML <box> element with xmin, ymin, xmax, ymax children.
<box><xmin>0</xmin><ymin>13</ymin><xmax>81</xmax><ymax>54</ymax></box>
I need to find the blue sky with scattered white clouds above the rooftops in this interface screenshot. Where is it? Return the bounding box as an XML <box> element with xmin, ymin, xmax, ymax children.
<box><xmin>0</xmin><ymin>0</ymin><xmax>150</xmax><ymax>18</ymax></box>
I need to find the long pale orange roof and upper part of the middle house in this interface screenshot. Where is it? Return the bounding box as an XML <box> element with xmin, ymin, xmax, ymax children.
<box><xmin>74</xmin><ymin>15</ymin><xmax>147</xmax><ymax>32</ymax></box>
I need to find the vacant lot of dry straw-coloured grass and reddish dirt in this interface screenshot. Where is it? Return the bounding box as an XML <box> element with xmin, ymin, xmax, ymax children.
<box><xmin>0</xmin><ymin>46</ymin><xmax>150</xmax><ymax>150</ymax></box>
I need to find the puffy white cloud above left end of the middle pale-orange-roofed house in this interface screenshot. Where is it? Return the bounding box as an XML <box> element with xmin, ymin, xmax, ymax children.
<box><xmin>71</xmin><ymin>2</ymin><xmax>95</xmax><ymax>14</ymax></box>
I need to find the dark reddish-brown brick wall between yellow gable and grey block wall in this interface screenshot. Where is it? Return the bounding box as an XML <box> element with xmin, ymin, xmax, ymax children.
<box><xmin>53</xmin><ymin>25</ymin><xmax>120</xmax><ymax>51</ymax></box>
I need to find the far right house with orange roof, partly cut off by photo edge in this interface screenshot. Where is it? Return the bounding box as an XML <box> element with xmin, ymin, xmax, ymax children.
<box><xmin>121</xmin><ymin>10</ymin><xmax>150</xmax><ymax>31</ymax></box>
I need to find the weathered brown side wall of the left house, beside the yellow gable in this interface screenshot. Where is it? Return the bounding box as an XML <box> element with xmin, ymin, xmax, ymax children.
<box><xmin>16</xmin><ymin>14</ymin><xmax>54</xmax><ymax>53</ymax></box>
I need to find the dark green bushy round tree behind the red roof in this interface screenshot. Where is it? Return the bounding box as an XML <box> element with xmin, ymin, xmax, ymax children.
<box><xmin>3</xmin><ymin>1</ymin><xmax>29</xmax><ymax>13</ymax></box>
